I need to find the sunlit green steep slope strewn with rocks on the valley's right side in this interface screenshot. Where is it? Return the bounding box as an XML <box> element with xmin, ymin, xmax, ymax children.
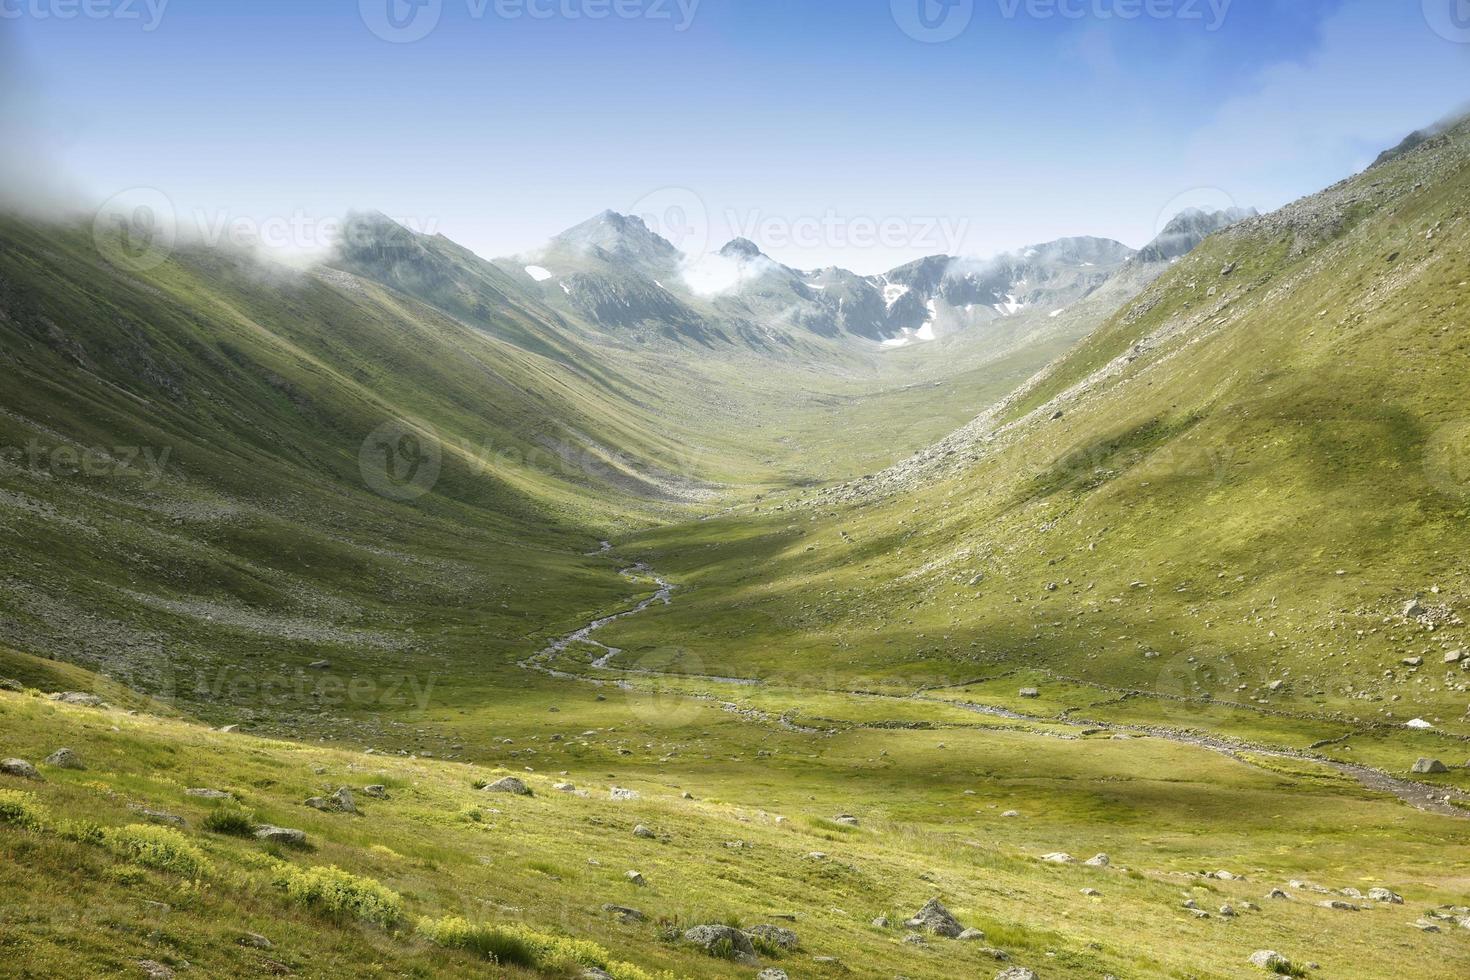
<box><xmin>607</xmin><ymin>122</ymin><xmax>1470</xmax><ymax>764</ymax></box>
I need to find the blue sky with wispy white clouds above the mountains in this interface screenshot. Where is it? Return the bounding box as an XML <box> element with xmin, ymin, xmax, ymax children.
<box><xmin>0</xmin><ymin>0</ymin><xmax>1470</xmax><ymax>273</ymax></box>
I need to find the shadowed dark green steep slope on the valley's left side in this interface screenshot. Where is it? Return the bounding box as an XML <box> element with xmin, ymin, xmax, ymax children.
<box><xmin>0</xmin><ymin>219</ymin><xmax>717</xmax><ymax>717</ymax></box>
